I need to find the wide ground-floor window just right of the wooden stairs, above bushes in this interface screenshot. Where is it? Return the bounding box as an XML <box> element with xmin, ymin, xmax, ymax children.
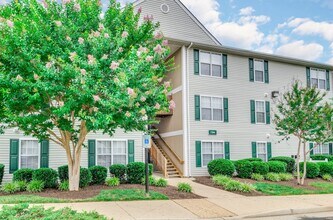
<box><xmin>201</xmin><ymin>141</ymin><xmax>224</xmax><ymax>167</ymax></box>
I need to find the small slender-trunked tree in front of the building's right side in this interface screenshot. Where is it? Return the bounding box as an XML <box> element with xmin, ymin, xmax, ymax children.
<box><xmin>274</xmin><ymin>81</ymin><xmax>332</xmax><ymax>185</ymax></box>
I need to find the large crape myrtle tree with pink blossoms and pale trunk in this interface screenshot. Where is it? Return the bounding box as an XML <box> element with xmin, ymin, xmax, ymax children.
<box><xmin>0</xmin><ymin>0</ymin><xmax>171</xmax><ymax>191</ymax></box>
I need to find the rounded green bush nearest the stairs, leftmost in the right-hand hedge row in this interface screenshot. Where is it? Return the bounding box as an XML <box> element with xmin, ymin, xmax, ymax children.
<box><xmin>207</xmin><ymin>159</ymin><xmax>235</xmax><ymax>176</ymax></box>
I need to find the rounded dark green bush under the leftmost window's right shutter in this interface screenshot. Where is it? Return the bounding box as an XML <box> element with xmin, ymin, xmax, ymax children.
<box><xmin>32</xmin><ymin>168</ymin><xmax>58</xmax><ymax>188</ymax></box>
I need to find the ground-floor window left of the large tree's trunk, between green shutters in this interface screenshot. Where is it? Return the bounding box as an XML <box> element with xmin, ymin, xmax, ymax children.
<box><xmin>19</xmin><ymin>139</ymin><xmax>40</xmax><ymax>169</ymax></box>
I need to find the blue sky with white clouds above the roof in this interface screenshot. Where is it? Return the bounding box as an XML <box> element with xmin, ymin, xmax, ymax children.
<box><xmin>0</xmin><ymin>0</ymin><xmax>333</xmax><ymax>65</ymax></box>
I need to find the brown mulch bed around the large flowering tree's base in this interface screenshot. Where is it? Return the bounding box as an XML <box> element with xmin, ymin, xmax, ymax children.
<box><xmin>0</xmin><ymin>184</ymin><xmax>203</xmax><ymax>200</ymax></box>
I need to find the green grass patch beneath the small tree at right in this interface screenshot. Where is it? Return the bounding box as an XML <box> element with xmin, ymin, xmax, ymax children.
<box><xmin>253</xmin><ymin>182</ymin><xmax>333</xmax><ymax>196</ymax></box>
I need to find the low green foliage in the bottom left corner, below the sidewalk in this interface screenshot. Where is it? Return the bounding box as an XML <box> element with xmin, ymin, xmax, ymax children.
<box><xmin>0</xmin><ymin>204</ymin><xmax>107</xmax><ymax>220</ymax></box>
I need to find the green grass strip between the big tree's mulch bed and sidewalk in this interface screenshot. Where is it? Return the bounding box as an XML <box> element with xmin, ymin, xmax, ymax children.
<box><xmin>0</xmin><ymin>189</ymin><xmax>169</xmax><ymax>204</ymax></box>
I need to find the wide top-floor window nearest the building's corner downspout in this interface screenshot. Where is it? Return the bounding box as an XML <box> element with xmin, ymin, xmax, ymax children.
<box><xmin>200</xmin><ymin>51</ymin><xmax>222</xmax><ymax>77</ymax></box>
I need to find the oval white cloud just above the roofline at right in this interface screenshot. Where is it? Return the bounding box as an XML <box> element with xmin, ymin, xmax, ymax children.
<box><xmin>276</xmin><ymin>40</ymin><xmax>324</xmax><ymax>60</ymax></box>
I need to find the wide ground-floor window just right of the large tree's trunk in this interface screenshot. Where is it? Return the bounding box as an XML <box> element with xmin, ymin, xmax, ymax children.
<box><xmin>96</xmin><ymin>140</ymin><xmax>127</xmax><ymax>167</ymax></box>
